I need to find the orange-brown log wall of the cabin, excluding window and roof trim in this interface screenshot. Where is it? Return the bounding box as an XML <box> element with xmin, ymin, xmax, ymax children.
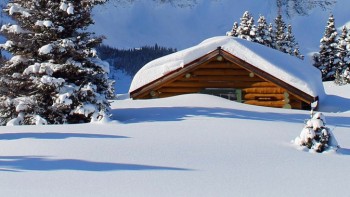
<box><xmin>143</xmin><ymin>60</ymin><xmax>302</xmax><ymax>109</ymax></box>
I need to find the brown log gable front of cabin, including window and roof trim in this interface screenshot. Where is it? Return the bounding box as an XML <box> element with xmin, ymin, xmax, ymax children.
<box><xmin>130</xmin><ymin>48</ymin><xmax>316</xmax><ymax>109</ymax></box>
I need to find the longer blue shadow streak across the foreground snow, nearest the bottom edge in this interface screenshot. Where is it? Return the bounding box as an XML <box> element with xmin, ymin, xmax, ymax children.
<box><xmin>0</xmin><ymin>156</ymin><xmax>190</xmax><ymax>172</ymax></box>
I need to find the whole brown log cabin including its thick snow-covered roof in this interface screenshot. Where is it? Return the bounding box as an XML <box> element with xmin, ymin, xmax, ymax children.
<box><xmin>129</xmin><ymin>36</ymin><xmax>324</xmax><ymax>109</ymax></box>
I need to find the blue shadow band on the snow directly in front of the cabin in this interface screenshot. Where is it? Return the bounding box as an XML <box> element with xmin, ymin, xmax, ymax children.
<box><xmin>112</xmin><ymin>107</ymin><xmax>350</xmax><ymax>127</ymax></box>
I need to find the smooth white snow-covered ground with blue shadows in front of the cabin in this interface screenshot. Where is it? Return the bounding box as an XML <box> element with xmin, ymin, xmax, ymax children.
<box><xmin>0</xmin><ymin>83</ymin><xmax>350</xmax><ymax>197</ymax></box>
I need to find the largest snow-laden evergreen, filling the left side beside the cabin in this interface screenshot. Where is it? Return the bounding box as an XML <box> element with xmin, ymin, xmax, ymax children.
<box><xmin>0</xmin><ymin>0</ymin><xmax>113</xmax><ymax>125</ymax></box>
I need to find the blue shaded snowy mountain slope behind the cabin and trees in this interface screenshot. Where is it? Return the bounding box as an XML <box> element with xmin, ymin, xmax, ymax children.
<box><xmin>91</xmin><ymin>0</ymin><xmax>350</xmax><ymax>54</ymax></box>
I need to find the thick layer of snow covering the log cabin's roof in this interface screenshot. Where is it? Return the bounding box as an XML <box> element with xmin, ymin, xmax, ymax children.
<box><xmin>129</xmin><ymin>36</ymin><xmax>324</xmax><ymax>97</ymax></box>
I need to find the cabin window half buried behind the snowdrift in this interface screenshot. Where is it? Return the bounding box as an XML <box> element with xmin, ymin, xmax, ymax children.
<box><xmin>201</xmin><ymin>88</ymin><xmax>242</xmax><ymax>102</ymax></box>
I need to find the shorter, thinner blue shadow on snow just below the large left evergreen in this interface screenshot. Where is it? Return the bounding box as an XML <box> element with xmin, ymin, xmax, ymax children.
<box><xmin>0</xmin><ymin>133</ymin><xmax>129</xmax><ymax>140</ymax></box>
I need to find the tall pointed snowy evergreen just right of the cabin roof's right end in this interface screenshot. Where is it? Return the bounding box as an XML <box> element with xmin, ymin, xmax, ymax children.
<box><xmin>313</xmin><ymin>15</ymin><xmax>339</xmax><ymax>81</ymax></box>
